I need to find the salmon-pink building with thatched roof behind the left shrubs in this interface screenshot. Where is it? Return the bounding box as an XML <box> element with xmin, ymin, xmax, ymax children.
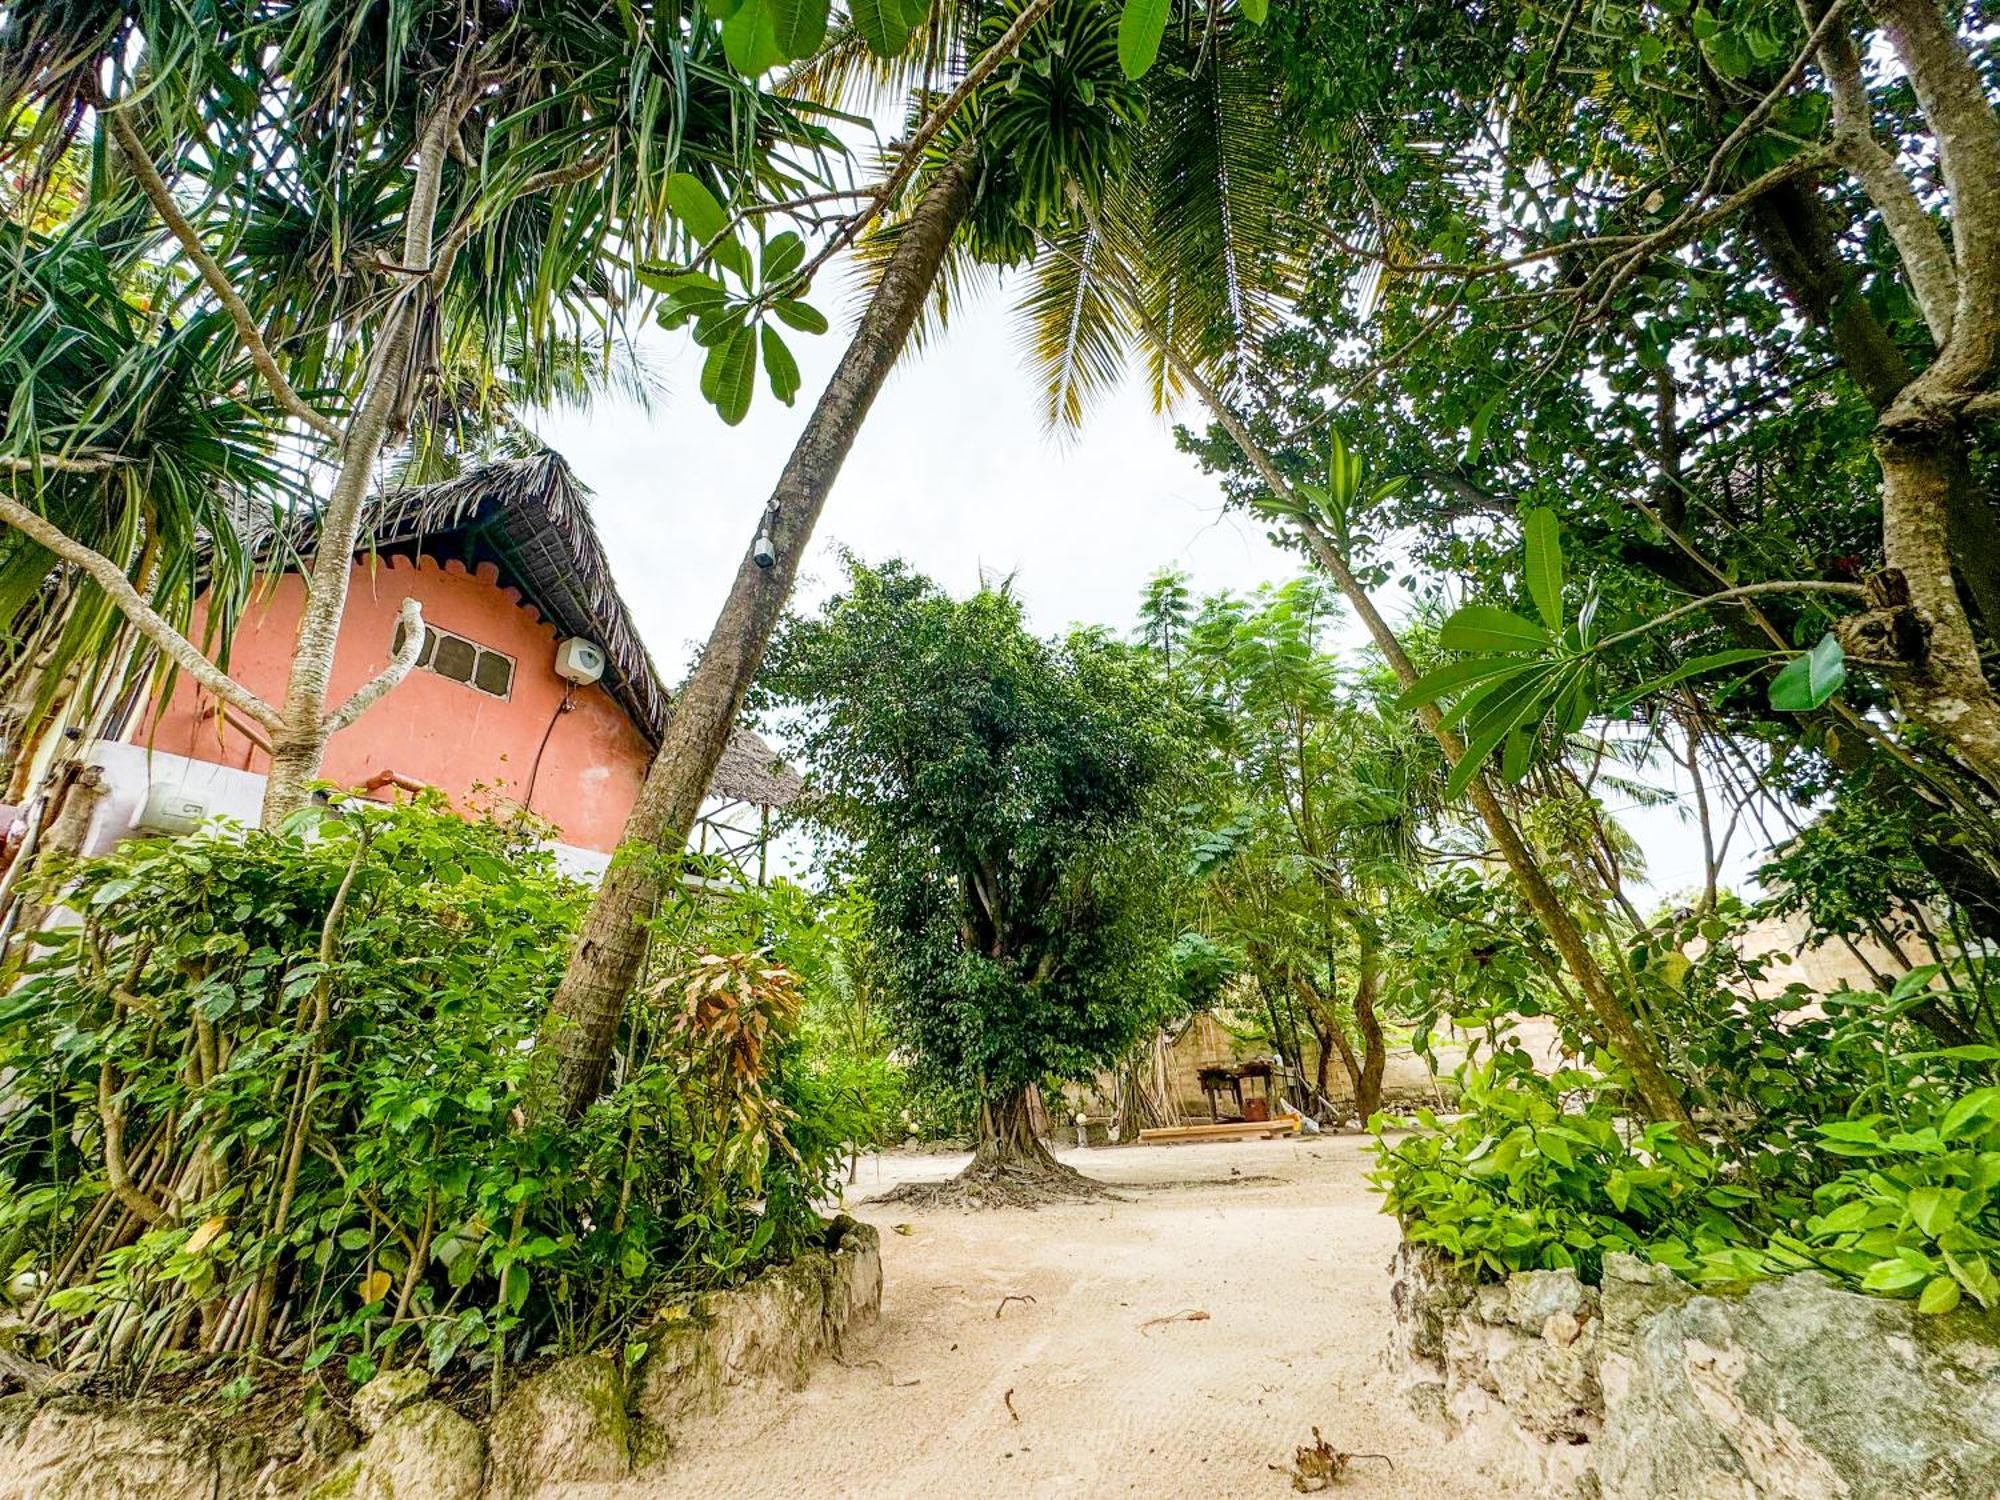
<box><xmin>99</xmin><ymin>454</ymin><xmax>798</xmax><ymax>870</ymax></box>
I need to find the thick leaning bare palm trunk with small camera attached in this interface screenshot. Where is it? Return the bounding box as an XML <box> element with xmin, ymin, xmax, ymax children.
<box><xmin>546</xmin><ymin>150</ymin><xmax>974</xmax><ymax>1116</ymax></box>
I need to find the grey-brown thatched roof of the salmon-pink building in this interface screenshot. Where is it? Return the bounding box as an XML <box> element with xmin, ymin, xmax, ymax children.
<box><xmin>284</xmin><ymin>452</ymin><xmax>800</xmax><ymax>808</ymax></box>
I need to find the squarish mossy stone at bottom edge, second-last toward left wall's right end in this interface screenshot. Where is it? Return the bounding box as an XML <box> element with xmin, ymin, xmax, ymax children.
<box><xmin>486</xmin><ymin>1354</ymin><xmax>632</xmax><ymax>1500</ymax></box>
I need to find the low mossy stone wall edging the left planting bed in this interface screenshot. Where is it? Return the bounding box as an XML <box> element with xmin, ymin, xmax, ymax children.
<box><xmin>0</xmin><ymin>1216</ymin><xmax>882</xmax><ymax>1500</ymax></box>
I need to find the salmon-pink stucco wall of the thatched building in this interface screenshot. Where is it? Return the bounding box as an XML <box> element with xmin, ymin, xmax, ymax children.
<box><xmin>143</xmin><ymin>558</ymin><xmax>652</xmax><ymax>852</ymax></box>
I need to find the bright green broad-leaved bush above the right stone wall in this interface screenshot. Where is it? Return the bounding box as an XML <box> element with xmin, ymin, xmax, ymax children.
<box><xmin>1376</xmin><ymin>1024</ymin><xmax>2000</xmax><ymax>1312</ymax></box>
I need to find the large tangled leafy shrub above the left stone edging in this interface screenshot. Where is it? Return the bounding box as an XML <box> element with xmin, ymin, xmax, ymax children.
<box><xmin>0</xmin><ymin>802</ymin><xmax>838</xmax><ymax>1380</ymax></box>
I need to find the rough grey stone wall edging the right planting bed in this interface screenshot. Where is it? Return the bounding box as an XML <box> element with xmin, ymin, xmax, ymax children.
<box><xmin>1390</xmin><ymin>1246</ymin><xmax>2000</xmax><ymax>1500</ymax></box>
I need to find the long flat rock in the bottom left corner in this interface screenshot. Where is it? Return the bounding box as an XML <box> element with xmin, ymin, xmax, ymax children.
<box><xmin>0</xmin><ymin>1398</ymin><xmax>258</xmax><ymax>1500</ymax></box>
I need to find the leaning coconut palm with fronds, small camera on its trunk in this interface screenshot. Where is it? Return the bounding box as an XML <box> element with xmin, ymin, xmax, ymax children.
<box><xmin>550</xmin><ymin>0</ymin><xmax>1282</xmax><ymax>1114</ymax></box>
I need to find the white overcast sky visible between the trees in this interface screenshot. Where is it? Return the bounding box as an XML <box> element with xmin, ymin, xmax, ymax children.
<box><xmin>538</xmin><ymin>272</ymin><xmax>1744</xmax><ymax>894</ymax></box>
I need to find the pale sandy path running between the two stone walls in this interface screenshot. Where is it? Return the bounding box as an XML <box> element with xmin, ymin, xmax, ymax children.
<box><xmin>592</xmin><ymin>1136</ymin><xmax>1506</xmax><ymax>1500</ymax></box>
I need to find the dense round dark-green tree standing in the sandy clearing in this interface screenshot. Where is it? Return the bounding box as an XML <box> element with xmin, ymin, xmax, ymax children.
<box><xmin>760</xmin><ymin>560</ymin><xmax>1192</xmax><ymax>1200</ymax></box>
